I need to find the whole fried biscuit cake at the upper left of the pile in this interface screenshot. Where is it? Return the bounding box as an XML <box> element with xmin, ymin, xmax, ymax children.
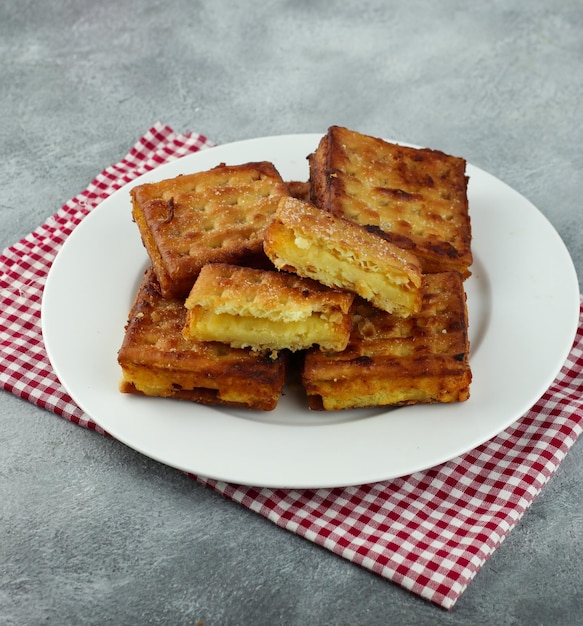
<box><xmin>131</xmin><ymin>162</ymin><xmax>289</xmax><ymax>298</ymax></box>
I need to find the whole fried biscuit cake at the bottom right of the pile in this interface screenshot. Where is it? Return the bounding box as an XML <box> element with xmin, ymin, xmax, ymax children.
<box><xmin>302</xmin><ymin>272</ymin><xmax>472</xmax><ymax>410</ymax></box>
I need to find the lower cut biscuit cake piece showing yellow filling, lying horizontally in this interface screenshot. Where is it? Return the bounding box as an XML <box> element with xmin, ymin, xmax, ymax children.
<box><xmin>183</xmin><ymin>263</ymin><xmax>354</xmax><ymax>351</ymax></box>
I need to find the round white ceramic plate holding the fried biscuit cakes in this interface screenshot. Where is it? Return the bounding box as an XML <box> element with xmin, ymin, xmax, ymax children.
<box><xmin>42</xmin><ymin>134</ymin><xmax>579</xmax><ymax>488</ymax></box>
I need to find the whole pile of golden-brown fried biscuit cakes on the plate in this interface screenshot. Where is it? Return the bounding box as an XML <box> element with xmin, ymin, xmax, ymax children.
<box><xmin>118</xmin><ymin>126</ymin><xmax>472</xmax><ymax>410</ymax></box>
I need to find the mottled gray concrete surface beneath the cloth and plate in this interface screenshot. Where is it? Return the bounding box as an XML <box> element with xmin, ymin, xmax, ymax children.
<box><xmin>0</xmin><ymin>0</ymin><xmax>583</xmax><ymax>626</ymax></box>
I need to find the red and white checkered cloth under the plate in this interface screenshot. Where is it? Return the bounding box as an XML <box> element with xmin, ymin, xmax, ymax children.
<box><xmin>0</xmin><ymin>124</ymin><xmax>583</xmax><ymax>609</ymax></box>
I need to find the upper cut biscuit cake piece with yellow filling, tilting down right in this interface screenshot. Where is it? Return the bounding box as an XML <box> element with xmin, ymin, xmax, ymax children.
<box><xmin>263</xmin><ymin>198</ymin><xmax>421</xmax><ymax>317</ymax></box>
